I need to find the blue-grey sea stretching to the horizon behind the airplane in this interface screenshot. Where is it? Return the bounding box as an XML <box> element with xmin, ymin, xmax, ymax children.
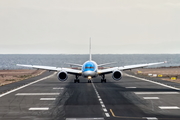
<box><xmin>0</xmin><ymin>54</ymin><xmax>180</xmax><ymax>70</ymax></box>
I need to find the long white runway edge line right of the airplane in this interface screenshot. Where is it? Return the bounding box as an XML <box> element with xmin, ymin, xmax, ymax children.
<box><xmin>125</xmin><ymin>73</ymin><xmax>180</xmax><ymax>91</ymax></box>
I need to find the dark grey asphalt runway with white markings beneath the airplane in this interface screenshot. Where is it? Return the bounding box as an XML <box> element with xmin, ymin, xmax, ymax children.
<box><xmin>0</xmin><ymin>72</ymin><xmax>180</xmax><ymax>120</ymax></box>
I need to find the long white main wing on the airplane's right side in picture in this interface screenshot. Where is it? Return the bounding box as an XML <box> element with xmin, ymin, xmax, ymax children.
<box><xmin>98</xmin><ymin>61</ymin><xmax>167</xmax><ymax>74</ymax></box>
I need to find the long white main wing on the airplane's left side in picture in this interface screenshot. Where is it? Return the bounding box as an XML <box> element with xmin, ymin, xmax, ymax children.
<box><xmin>17</xmin><ymin>64</ymin><xmax>82</xmax><ymax>75</ymax></box>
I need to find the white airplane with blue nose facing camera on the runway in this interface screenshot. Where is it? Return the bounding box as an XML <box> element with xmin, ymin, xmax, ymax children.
<box><xmin>17</xmin><ymin>40</ymin><xmax>166</xmax><ymax>83</ymax></box>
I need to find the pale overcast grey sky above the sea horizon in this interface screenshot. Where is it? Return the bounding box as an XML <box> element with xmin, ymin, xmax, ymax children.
<box><xmin>0</xmin><ymin>0</ymin><xmax>180</xmax><ymax>54</ymax></box>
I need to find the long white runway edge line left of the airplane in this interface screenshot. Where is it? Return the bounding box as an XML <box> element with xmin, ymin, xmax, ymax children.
<box><xmin>0</xmin><ymin>72</ymin><xmax>56</xmax><ymax>97</ymax></box>
